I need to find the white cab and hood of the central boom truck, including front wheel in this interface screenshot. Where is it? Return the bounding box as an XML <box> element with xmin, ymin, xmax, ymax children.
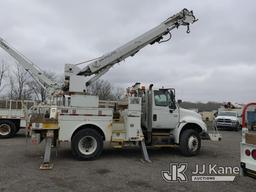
<box><xmin>142</xmin><ymin>85</ymin><xmax>209</xmax><ymax>156</ymax></box>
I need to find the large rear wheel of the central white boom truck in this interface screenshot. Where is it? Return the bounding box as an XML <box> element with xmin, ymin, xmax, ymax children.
<box><xmin>71</xmin><ymin>129</ymin><xmax>103</xmax><ymax>160</ymax></box>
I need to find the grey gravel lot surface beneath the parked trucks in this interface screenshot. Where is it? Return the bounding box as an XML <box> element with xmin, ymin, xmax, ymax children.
<box><xmin>0</xmin><ymin>131</ymin><xmax>256</xmax><ymax>192</ymax></box>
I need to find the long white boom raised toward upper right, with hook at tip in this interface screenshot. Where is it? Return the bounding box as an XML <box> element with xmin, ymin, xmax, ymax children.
<box><xmin>65</xmin><ymin>9</ymin><xmax>197</xmax><ymax>89</ymax></box>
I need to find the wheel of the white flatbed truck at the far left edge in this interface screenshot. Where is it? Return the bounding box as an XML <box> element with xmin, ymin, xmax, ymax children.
<box><xmin>0</xmin><ymin>120</ymin><xmax>17</xmax><ymax>138</ymax></box>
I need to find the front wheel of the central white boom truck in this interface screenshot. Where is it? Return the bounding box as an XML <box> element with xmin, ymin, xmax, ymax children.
<box><xmin>180</xmin><ymin>129</ymin><xmax>201</xmax><ymax>156</ymax></box>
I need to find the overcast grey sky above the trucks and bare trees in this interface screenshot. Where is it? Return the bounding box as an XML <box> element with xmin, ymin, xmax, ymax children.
<box><xmin>0</xmin><ymin>0</ymin><xmax>256</xmax><ymax>102</ymax></box>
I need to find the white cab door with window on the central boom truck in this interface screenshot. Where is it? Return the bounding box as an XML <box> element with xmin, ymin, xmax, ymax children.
<box><xmin>152</xmin><ymin>89</ymin><xmax>179</xmax><ymax>129</ymax></box>
